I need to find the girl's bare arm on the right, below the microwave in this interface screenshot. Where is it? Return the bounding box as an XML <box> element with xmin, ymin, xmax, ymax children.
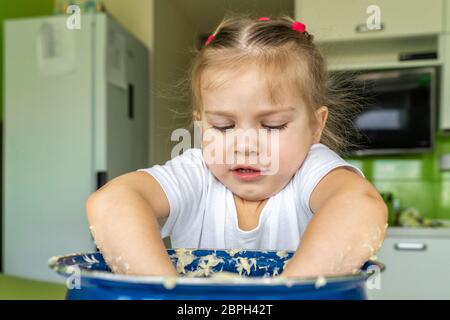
<box><xmin>281</xmin><ymin>167</ymin><xmax>387</xmax><ymax>277</ymax></box>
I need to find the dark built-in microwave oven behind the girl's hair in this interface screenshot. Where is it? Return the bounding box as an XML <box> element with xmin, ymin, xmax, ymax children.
<box><xmin>340</xmin><ymin>67</ymin><xmax>438</xmax><ymax>155</ymax></box>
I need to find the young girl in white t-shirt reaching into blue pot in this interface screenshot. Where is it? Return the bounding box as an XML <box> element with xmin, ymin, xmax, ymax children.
<box><xmin>86</xmin><ymin>17</ymin><xmax>387</xmax><ymax>277</ymax></box>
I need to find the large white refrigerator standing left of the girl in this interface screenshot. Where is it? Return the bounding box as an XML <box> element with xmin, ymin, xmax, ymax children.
<box><xmin>1</xmin><ymin>13</ymin><xmax>149</xmax><ymax>282</ymax></box>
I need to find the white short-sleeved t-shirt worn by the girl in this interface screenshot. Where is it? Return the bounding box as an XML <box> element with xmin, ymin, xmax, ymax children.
<box><xmin>138</xmin><ymin>143</ymin><xmax>364</xmax><ymax>251</ymax></box>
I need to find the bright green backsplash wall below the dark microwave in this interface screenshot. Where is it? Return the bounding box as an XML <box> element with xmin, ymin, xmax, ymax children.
<box><xmin>348</xmin><ymin>133</ymin><xmax>450</xmax><ymax>219</ymax></box>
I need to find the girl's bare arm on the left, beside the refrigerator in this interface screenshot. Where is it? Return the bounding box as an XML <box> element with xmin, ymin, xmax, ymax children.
<box><xmin>86</xmin><ymin>172</ymin><xmax>177</xmax><ymax>276</ymax></box>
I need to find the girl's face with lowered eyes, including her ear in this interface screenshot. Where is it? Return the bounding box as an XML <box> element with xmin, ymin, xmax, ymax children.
<box><xmin>200</xmin><ymin>67</ymin><xmax>327</xmax><ymax>201</ymax></box>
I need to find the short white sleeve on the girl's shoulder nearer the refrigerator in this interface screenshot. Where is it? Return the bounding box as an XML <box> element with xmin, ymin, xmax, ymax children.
<box><xmin>137</xmin><ymin>149</ymin><xmax>207</xmax><ymax>238</ymax></box>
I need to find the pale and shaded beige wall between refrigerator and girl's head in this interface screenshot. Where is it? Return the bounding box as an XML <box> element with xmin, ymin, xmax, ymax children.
<box><xmin>104</xmin><ymin>0</ymin><xmax>196</xmax><ymax>166</ymax></box>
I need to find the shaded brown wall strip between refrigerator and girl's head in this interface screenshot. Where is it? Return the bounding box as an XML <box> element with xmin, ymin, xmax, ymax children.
<box><xmin>152</xmin><ymin>0</ymin><xmax>196</xmax><ymax>163</ymax></box>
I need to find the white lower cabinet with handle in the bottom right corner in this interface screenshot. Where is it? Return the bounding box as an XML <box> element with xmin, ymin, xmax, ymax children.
<box><xmin>368</xmin><ymin>230</ymin><xmax>450</xmax><ymax>299</ymax></box>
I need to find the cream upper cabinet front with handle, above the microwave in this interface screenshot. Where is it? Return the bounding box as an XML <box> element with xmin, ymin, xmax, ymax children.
<box><xmin>295</xmin><ymin>0</ymin><xmax>444</xmax><ymax>41</ymax></box>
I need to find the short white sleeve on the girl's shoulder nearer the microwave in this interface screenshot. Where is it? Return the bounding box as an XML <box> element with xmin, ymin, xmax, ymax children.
<box><xmin>293</xmin><ymin>143</ymin><xmax>365</xmax><ymax>216</ymax></box>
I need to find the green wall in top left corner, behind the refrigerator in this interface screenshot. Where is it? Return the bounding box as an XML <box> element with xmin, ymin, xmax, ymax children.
<box><xmin>0</xmin><ymin>0</ymin><xmax>54</xmax><ymax>121</ymax></box>
